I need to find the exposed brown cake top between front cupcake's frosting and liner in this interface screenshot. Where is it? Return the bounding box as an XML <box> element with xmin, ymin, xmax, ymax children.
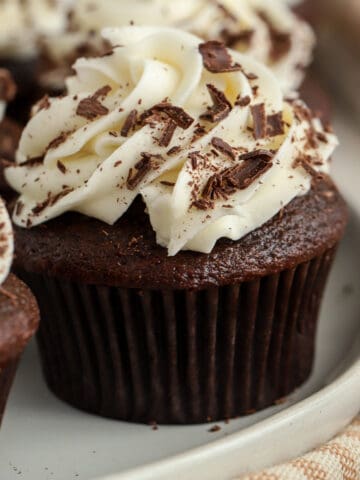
<box><xmin>15</xmin><ymin>178</ymin><xmax>347</xmax><ymax>290</ymax></box>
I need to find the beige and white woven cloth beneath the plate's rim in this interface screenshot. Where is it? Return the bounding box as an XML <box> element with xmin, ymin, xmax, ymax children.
<box><xmin>238</xmin><ymin>417</ymin><xmax>360</xmax><ymax>480</ymax></box>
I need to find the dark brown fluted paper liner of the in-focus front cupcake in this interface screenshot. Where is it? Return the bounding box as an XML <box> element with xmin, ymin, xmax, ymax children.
<box><xmin>21</xmin><ymin>249</ymin><xmax>335</xmax><ymax>423</ymax></box>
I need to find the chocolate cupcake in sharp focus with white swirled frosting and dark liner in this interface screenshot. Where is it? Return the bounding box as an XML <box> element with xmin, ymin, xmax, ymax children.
<box><xmin>6</xmin><ymin>27</ymin><xmax>347</xmax><ymax>423</ymax></box>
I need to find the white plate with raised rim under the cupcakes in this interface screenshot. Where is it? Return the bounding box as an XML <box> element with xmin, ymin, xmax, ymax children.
<box><xmin>0</xmin><ymin>109</ymin><xmax>360</xmax><ymax>480</ymax></box>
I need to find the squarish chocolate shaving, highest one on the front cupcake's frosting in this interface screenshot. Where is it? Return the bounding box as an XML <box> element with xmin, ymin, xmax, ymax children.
<box><xmin>199</xmin><ymin>40</ymin><xmax>241</xmax><ymax>73</ymax></box>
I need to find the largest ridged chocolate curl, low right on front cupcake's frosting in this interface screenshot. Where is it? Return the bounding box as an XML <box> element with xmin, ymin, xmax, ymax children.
<box><xmin>202</xmin><ymin>152</ymin><xmax>272</xmax><ymax>200</ymax></box>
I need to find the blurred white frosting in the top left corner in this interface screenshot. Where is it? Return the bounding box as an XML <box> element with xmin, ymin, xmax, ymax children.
<box><xmin>0</xmin><ymin>0</ymin><xmax>69</xmax><ymax>58</ymax></box>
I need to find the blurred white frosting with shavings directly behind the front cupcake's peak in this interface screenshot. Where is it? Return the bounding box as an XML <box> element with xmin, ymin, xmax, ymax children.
<box><xmin>47</xmin><ymin>0</ymin><xmax>314</xmax><ymax>91</ymax></box>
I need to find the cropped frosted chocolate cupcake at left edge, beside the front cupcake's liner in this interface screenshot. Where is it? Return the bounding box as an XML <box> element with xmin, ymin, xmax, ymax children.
<box><xmin>0</xmin><ymin>198</ymin><xmax>39</xmax><ymax>423</ymax></box>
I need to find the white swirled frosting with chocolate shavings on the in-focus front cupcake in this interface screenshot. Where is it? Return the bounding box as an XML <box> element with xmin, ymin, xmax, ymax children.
<box><xmin>6</xmin><ymin>27</ymin><xmax>337</xmax><ymax>255</ymax></box>
